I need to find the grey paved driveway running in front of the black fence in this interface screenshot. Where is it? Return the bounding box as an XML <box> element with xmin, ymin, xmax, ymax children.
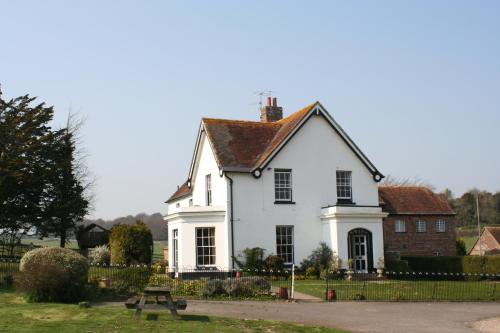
<box><xmin>184</xmin><ymin>300</ymin><xmax>500</xmax><ymax>333</ymax></box>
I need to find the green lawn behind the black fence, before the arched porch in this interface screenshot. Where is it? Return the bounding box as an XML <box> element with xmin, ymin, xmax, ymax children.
<box><xmin>295</xmin><ymin>280</ymin><xmax>500</xmax><ymax>301</ymax></box>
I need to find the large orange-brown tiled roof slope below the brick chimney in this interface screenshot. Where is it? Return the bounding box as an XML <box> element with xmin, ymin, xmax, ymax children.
<box><xmin>202</xmin><ymin>103</ymin><xmax>316</xmax><ymax>172</ymax></box>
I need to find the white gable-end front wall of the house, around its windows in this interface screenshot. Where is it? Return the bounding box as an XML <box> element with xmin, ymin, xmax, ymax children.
<box><xmin>231</xmin><ymin>116</ymin><xmax>383</xmax><ymax>264</ymax></box>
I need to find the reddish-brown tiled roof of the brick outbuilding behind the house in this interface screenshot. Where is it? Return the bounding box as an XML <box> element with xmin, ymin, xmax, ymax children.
<box><xmin>378</xmin><ymin>186</ymin><xmax>454</xmax><ymax>215</ymax></box>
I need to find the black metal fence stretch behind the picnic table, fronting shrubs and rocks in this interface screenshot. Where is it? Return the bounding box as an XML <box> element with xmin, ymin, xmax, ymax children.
<box><xmin>0</xmin><ymin>260</ymin><xmax>292</xmax><ymax>299</ymax></box>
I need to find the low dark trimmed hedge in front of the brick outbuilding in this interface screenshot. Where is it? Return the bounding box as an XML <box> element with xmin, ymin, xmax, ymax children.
<box><xmin>401</xmin><ymin>256</ymin><xmax>500</xmax><ymax>274</ymax></box>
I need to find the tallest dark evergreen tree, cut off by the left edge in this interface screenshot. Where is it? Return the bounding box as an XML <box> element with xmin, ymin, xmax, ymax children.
<box><xmin>0</xmin><ymin>90</ymin><xmax>53</xmax><ymax>251</ymax></box>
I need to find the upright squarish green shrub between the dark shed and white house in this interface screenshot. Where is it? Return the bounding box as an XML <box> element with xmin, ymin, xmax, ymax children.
<box><xmin>109</xmin><ymin>221</ymin><xmax>153</xmax><ymax>265</ymax></box>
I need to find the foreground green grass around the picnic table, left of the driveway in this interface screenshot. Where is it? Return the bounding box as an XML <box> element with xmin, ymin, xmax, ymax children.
<box><xmin>0</xmin><ymin>291</ymin><xmax>345</xmax><ymax>333</ymax></box>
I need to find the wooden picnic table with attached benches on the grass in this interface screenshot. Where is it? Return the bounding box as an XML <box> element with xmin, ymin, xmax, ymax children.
<box><xmin>125</xmin><ymin>287</ymin><xmax>187</xmax><ymax>320</ymax></box>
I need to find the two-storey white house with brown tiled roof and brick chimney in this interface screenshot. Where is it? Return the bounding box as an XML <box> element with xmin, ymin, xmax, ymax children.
<box><xmin>165</xmin><ymin>98</ymin><xmax>387</xmax><ymax>272</ymax></box>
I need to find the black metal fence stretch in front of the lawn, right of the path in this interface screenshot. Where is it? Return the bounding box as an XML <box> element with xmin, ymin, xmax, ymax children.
<box><xmin>323</xmin><ymin>272</ymin><xmax>500</xmax><ymax>301</ymax></box>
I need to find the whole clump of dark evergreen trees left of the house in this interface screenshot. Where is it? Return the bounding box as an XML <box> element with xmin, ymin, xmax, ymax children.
<box><xmin>0</xmin><ymin>85</ymin><xmax>91</xmax><ymax>252</ymax></box>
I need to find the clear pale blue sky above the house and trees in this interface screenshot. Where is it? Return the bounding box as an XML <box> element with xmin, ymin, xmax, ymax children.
<box><xmin>0</xmin><ymin>0</ymin><xmax>500</xmax><ymax>218</ymax></box>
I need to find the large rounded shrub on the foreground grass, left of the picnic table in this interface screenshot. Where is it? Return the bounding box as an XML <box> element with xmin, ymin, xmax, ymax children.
<box><xmin>16</xmin><ymin>248</ymin><xmax>89</xmax><ymax>302</ymax></box>
